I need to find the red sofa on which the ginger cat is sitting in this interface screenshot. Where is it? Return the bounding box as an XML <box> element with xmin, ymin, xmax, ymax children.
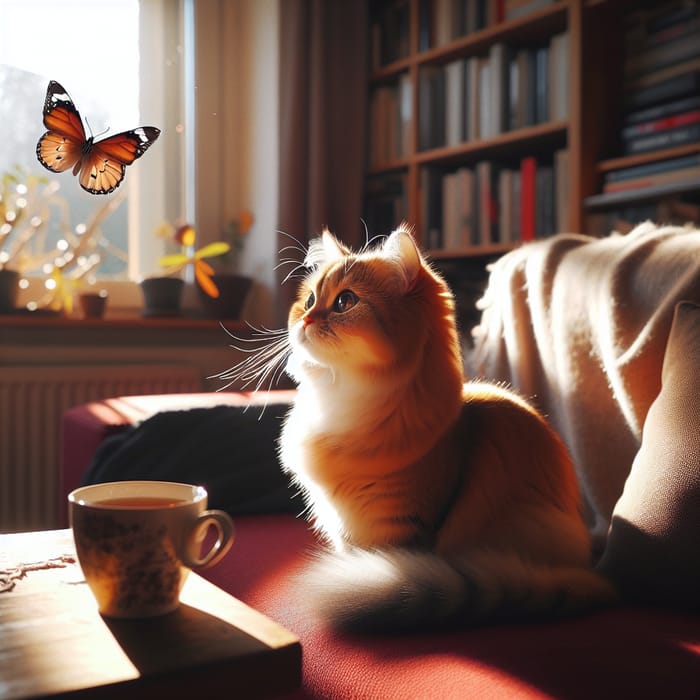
<box><xmin>60</xmin><ymin>392</ymin><xmax>700</xmax><ymax>700</ymax></box>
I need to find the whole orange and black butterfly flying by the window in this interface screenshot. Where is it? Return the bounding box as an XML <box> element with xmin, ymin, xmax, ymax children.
<box><xmin>36</xmin><ymin>80</ymin><xmax>160</xmax><ymax>194</ymax></box>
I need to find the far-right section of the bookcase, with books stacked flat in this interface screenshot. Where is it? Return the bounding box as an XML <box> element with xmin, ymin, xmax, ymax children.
<box><xmin>587</xmin><ymin>0</ymin><xmax>700</xmax><ymax>235</ymax></box>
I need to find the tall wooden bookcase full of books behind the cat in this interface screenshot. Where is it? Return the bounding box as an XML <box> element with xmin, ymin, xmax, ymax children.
<box><xmin>365</xmin><ymin>0</ymin><xmax>700</xmax><ymax>258</ymax></box>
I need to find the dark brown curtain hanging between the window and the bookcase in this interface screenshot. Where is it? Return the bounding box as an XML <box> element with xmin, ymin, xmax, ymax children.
<box><xmin>278</xmin><ymin>0</ymin><xmax>367</xmax><ymax>322</ymax></box>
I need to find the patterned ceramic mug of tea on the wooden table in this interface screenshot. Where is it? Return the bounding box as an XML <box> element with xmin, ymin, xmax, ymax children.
<box><xmin>68</xmin><ymin>481</ymin><xmax>234</xmax><ymax>617</ymax></box>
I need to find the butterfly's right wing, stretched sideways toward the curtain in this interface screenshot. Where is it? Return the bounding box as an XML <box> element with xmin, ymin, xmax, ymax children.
<box><xmin>79</xmin><ymin>126</ymin><xmax>160</xmax><ymax>194</ymax></box>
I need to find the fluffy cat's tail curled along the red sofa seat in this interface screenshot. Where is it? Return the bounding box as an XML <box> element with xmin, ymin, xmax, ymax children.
<box><xmin>304</xmin><ymin>549</ymin><xmax>617</xmax><ymax>633</ymax></box>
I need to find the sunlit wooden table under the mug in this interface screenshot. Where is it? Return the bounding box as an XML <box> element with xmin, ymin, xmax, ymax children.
<box><xmin>0</xmin><ymin>530</ymin><xmax>301</xmax><ymax>700</ymax></box>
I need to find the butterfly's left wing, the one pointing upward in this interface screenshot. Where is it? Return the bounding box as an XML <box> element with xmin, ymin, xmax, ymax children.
<box><xmin>36</xmin><ymin>80</ymin><xmax>86</xmax><ymax>173</ymax></box>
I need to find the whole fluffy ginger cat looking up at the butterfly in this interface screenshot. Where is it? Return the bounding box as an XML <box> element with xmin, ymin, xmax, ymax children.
<box><xmin>249</xmin><ymin>225</ymin><xmax>615</xmax><ymax>632</ymax></box>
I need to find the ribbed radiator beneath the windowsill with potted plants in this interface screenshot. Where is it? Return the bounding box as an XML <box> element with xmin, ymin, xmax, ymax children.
<box><xmin>0</xmin><ymin>365</ymin><xmax>202</xmax><ymax>532</ymax></box>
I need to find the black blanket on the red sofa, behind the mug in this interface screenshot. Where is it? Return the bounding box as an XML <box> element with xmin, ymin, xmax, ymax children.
<box><xmin>81</xmin><ymin>404</ymin><xmax>303</xmax><ymax>515</ymax></box>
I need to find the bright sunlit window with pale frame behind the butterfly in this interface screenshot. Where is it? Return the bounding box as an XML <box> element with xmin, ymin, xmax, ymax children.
<box><xmin>0</xmin><ymin>0</ymin><xmax>194</xmax><ymax>288</ymax></box>
